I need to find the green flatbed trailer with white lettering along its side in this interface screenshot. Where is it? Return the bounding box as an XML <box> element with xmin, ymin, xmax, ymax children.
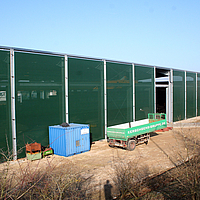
<box><xmin>107</xmin><ymin>113</ymin><xmax>167</xmax><ymax>151</ymax></box>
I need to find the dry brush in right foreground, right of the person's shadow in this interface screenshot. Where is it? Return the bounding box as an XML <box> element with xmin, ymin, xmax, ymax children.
<box><xmin>113</xmin><ymin>129</ymin><xmax>200</xmax><ymax>200</ymax></box>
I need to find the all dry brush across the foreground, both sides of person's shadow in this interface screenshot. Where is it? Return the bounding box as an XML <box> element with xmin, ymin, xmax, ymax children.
<box><xmin>0</xmin><ymin>125</ymin><xmax>200</xmax><ymax>200</ymax></box>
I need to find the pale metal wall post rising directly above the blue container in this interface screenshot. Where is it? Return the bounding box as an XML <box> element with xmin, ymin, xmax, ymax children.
<box><xmin>65</xmin><ymin>55</ymin><xmax>69</xmax><ymax>123</ymax></box>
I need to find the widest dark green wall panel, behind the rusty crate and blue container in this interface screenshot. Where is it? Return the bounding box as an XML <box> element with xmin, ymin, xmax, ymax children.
<box><xmin>15</xmin><ymin>52</ymin><xmax>65</xmax><ymax>157</ymax></box>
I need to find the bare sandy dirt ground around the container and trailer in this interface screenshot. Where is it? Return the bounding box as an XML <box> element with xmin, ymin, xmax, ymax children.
<box><xmin>0</xmin><ymin>117</ymin><xmax>200</xmax><ymax>199</ymax></box>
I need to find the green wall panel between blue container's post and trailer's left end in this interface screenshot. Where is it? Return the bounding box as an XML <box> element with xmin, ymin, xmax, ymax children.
<box><xmin>68</xmin><ymin>58</ymin><xmax>105</xmax><ymax>141</ymax></box>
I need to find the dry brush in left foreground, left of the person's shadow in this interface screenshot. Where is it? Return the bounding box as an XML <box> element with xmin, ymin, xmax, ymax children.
<box><xmin>0</xmin><ymin>159</ymin><xmax>90</xmax><ymax>199</ymax></box>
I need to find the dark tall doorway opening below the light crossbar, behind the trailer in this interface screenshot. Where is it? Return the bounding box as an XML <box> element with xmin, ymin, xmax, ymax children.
<box><xmin>156</xmin><ymin>87</ymin><xmax>167</xmax><ymax>113</ymax></box>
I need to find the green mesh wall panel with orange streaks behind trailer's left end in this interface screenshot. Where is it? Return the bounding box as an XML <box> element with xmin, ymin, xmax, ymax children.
<box><xmin>106</xmin><ymin>62</ymin><xmax>133</xmax><ymax>126</ymax></box>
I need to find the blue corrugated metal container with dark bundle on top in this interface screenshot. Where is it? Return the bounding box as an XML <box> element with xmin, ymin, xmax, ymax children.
<box><xmin>49</xmin><ymin>123</ymin><xmax>90</xmax><ymax>156</ymax></box>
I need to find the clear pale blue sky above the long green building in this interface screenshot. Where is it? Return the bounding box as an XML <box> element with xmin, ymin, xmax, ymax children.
<box><xmin>0</xmin><ymin>0</ymin><xmax>200</xmax><ymax>72</ymax></box>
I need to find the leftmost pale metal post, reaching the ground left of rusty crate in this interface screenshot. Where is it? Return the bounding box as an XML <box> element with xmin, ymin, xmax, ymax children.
<box><xmin>10</xmin><ymin>49</ymin><xmax>17</xmax><ymax>160</ymax></box>
